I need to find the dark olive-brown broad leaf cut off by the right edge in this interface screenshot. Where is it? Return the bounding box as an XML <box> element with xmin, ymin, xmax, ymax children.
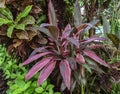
<box><xmin>107</xmin><ymin>34</ymin><xmax>120</xmax><ymax>49</ymax></box>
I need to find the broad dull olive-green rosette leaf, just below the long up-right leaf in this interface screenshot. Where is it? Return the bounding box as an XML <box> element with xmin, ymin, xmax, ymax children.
<box><xmin>21</xmin><ymin>15</ymin><xmax>35</xmax><ymax>26</ymax></box>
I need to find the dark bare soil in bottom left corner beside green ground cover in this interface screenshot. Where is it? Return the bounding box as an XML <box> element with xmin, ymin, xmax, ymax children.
<box><xmin>0</xmin><ymin>69</ymin><xmax>8</xmax><ymax>94</ymax></box>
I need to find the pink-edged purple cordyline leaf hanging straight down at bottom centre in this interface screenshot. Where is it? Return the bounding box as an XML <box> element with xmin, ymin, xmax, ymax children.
<box><xmin>59</xmin><ymin>60</ymin><xmax>71</xmax><ymax>90</ymax></box>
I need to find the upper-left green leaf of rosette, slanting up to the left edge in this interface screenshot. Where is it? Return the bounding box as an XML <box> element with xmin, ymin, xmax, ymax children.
<box><xmin>0</xmin><ymin>8</ymin><xmax>13</xmax><ymax>20</ymax></box>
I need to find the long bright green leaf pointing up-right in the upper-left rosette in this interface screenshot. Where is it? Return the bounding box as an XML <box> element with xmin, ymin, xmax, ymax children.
<box><xmin>16</xmin><ymin>5</ymin><xmax>32</xmax><ymax>23</ymax></box>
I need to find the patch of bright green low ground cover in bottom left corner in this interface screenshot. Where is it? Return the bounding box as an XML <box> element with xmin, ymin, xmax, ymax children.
<box><xmin>0</xmin><ymin>45</ymin><xmax>60</xmax><ymax>94</ymax></box>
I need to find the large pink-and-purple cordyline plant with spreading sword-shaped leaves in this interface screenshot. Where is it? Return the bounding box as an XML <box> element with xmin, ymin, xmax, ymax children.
<box><xmin>22</xmin><ymin>0</ymin><xmax>109</xmax><ymax>90</ymax></box>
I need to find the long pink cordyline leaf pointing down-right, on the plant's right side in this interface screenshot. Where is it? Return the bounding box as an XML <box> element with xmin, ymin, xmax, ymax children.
<box><xmin>83</xmin><ymin>50</ymin><xmax>110</xmax><ymax>67</ymax></box>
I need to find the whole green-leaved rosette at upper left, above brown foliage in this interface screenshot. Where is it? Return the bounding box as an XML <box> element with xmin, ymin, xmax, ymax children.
<box><xmin>0</xmin><ymin>5</ymin><xmax>35</xmax><ymax>38</ymax></box>
